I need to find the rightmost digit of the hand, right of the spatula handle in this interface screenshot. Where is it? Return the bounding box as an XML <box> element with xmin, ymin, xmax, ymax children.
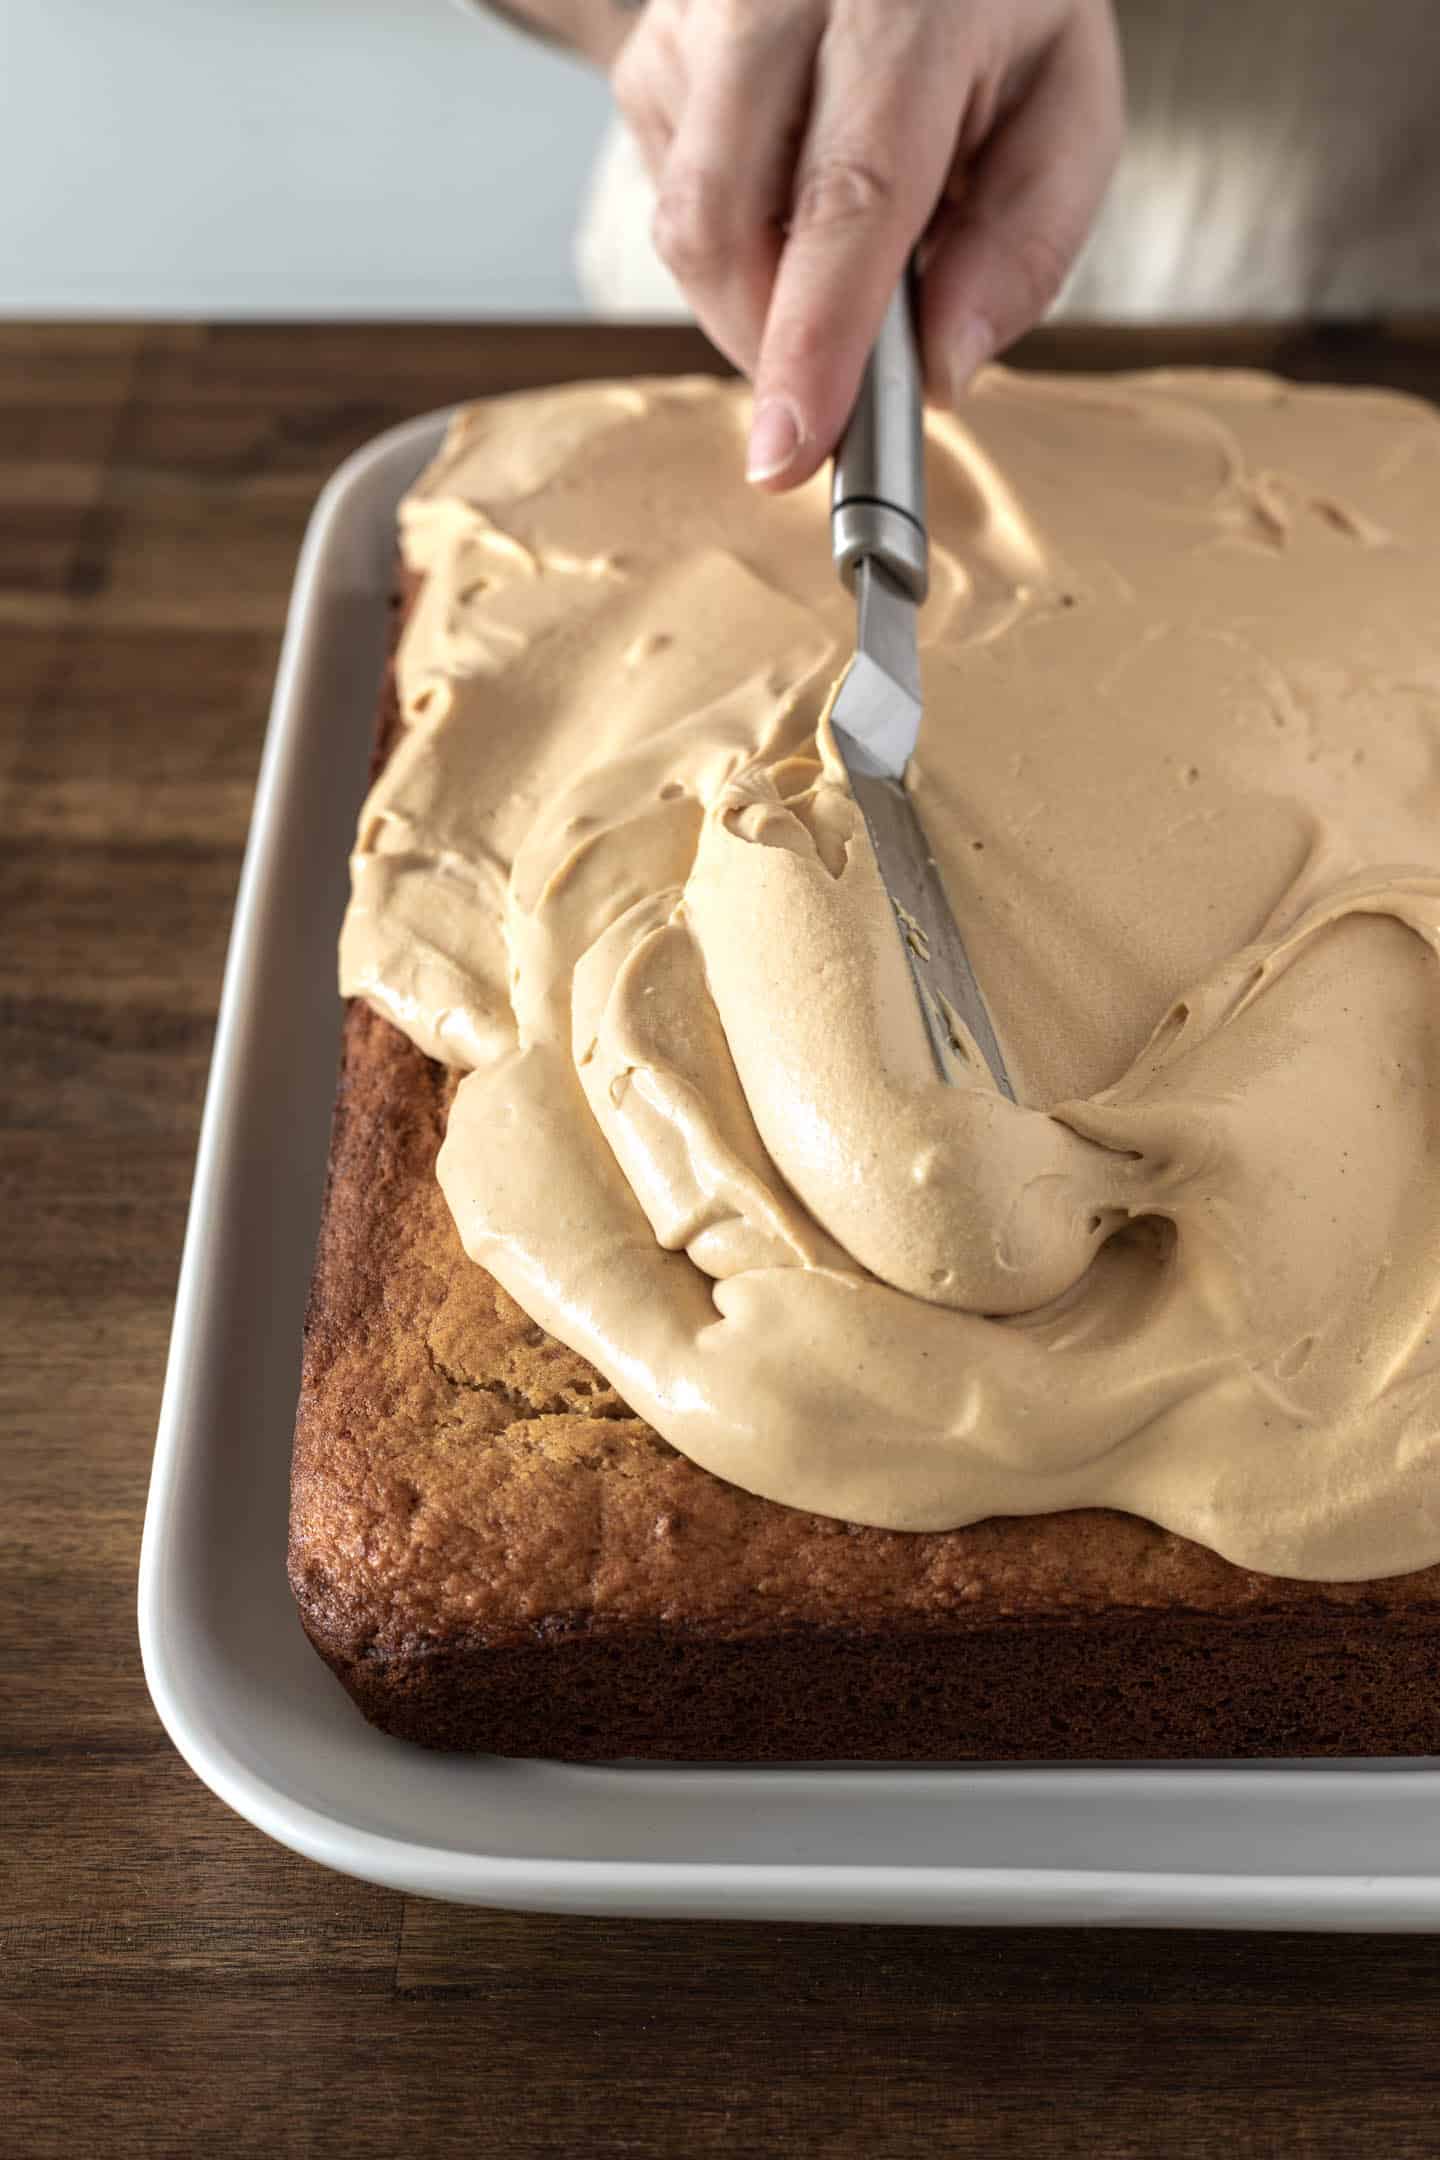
<box><xmin>922</xmin><ymin>9</ymin><xmax>1125</xmax><ymax>402</ymax></box>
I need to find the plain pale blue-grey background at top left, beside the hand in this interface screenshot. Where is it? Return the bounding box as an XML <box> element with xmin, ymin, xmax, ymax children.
<box><xmin>0</xmin><ymin>0</ymin><xmax>607</xmax><ymax>315</ymax></box>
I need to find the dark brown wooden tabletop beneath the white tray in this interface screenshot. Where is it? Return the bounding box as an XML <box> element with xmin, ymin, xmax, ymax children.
<box><xmin>0</xmin><ymin>326</ymin><xmax>1440</xmax><ymax>2160</ymax></box>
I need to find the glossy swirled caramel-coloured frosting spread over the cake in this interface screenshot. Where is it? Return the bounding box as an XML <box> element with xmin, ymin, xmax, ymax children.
<box><xmin>341</xmin><ymin>369</ymin><xmax>1440</xmax><ymax>1579</ymax></box>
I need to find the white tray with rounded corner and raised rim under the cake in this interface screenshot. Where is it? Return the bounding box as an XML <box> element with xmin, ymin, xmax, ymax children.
<box><xmin>140</xmin><ymin>415</ymin><xmax>1440</xmax><ymax>1929</ymax></box>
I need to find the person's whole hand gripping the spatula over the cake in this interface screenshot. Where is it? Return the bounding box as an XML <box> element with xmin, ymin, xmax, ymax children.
<box><xmin>613</xmin><ymin>0</ymin><xmax>1123</xmax><ymax>490</ymax></box>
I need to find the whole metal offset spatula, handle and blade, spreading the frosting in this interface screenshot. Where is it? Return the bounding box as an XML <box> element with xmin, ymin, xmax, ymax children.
<box><xmin>831</xmin><ymin>279</ymin><xmax>1015</xmax><ymax>1102</ymax></box>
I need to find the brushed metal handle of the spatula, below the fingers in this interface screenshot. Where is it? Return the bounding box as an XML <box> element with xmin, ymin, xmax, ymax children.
<box><xmin>831</xmin><ymin>266</ymin><xmax>930</xmax><ymax>600</ymax></box>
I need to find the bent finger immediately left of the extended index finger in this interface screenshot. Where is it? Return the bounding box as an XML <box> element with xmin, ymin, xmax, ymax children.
<box><xmin>652</xmin><ymin>0</ymin><xmax>823</xmax><ymax>372</ymax></box>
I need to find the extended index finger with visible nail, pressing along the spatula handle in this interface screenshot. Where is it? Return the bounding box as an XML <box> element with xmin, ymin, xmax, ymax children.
<box><xmin>747</xmin><ymin>0</ymin><xmax>969</xmax><ymax>488</ymax></box>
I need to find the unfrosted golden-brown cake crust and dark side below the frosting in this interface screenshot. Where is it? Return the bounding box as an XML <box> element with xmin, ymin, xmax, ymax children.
<box><xmin>289</xmin><ymin>587</ymin><xmax>1440</xmax><ymax>1760</ymax></box>
